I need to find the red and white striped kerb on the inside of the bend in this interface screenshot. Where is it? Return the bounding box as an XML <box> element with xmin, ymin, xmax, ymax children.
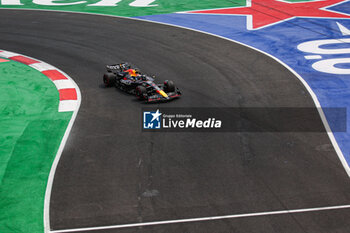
<box><xmin>0</xmin><ymin>50</ymin><xmax>80</xmax><ymax>112</ymax></box>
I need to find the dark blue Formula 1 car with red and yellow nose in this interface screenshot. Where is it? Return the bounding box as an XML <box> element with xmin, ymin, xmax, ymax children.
<box><xmin>103</xmin><ymin>63</ymin><xmax>181</xmax><ymax>102</ymax></box>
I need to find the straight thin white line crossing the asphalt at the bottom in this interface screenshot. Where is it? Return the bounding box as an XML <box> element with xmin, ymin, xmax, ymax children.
<box><xmin>50</xmin><ymin>205</ymin><xmax>350</xmax><ymax>233</ymax></box>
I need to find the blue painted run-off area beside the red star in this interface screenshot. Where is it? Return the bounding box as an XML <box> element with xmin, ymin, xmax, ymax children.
<box><xmin>138</xmin><ymin>2</ymin><xmax>350</xmax><ymax>164</ymax></box>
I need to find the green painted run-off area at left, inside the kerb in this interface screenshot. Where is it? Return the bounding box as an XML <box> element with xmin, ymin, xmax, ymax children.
<box><xmin>0</xmin><ymin>58</ymin><xmax>72</xmax><ymax>233</ymax></box>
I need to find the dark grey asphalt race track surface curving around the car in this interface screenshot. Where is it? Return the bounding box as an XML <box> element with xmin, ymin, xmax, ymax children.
<box><xmin>0</xmin><ymin>10</ymin><xmax>350</xmax><ymax>233</ymax></box>
